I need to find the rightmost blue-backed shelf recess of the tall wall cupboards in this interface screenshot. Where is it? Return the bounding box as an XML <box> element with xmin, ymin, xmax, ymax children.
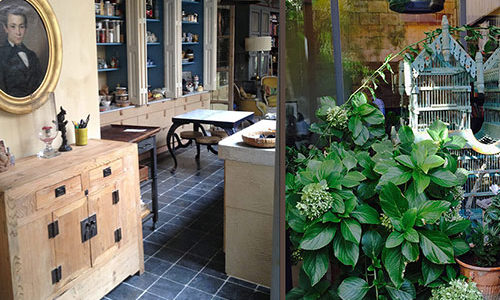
<box><xmin>182</xmin><ymin>0</ymin><xmax>204</xmax><ymax>84</ymax></box>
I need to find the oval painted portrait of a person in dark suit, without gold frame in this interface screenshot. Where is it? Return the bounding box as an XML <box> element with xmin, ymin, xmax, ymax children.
<box><xmin>0</xmin><ymin>0</ymin><xmax>49</xmax><ymax>97</ymax></box>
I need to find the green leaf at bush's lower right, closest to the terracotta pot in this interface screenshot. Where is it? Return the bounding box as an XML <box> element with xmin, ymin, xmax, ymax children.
<box><xmin>419</xmin><ymin>230</ymin><xmax>454</xmax><ymax>264</ymax></box>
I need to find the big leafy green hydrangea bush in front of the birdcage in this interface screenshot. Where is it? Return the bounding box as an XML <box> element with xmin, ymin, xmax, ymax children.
<box><xmin>286</xmin><ymin>93</ymin><xmax>470</xmax><ymax>299</ymax></box>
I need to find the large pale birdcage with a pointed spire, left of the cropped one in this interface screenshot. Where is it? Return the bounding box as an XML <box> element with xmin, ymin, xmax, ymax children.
<box><xmin>404</xmin><ymin>16</ymin><xmax>477</xmax><ymax>132</ymax></box>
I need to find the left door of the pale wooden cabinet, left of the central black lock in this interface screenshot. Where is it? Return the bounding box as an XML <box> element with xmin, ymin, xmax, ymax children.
<box><xmin>53</xmin><ymin>197</ymin><xmax>90</xmax><ymax>287</ymax></box>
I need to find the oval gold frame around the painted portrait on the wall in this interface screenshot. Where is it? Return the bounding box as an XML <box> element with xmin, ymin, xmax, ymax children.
<box><xmin>0</xmin><ymin>0</ymin><xmax>62</xmax><ymax>114</ymax></box>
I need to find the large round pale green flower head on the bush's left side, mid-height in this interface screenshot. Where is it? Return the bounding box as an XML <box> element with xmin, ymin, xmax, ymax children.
<box><xmin>297</xmin><ymin>183</ymin><xmax>333</xmax><ymax>220</ymax></box>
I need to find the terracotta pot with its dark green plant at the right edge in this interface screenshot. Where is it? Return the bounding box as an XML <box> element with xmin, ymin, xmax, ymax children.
<box><xmin>457</xmin><ymin>193</ymin><xmax>500</xmax><ymax>300</ymax></box>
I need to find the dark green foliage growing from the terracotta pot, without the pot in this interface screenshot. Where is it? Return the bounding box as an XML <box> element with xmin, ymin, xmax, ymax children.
<box><xmin>469</xmin><ymin>195</ymin><xmax>500</xmax><ymax>267</ymax></box>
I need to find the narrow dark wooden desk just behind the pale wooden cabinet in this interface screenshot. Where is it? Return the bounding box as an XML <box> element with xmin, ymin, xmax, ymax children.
<box><xmin>101</xmin><ymin>125</ymin><xmax>160</xmax><ymax>229</ymax></box>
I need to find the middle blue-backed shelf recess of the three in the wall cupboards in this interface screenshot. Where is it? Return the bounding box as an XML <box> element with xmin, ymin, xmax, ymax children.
<box><xmin>146</xmin><ymin>0</ymin><xmax>165</xmax><ymax>90</ymax></box>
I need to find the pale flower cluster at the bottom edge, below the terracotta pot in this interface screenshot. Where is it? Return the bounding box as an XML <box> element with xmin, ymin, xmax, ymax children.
<box><xmin>429</xmin><ymin>279</ymin><xmax>483</xmax><ymax>300</ymax></box>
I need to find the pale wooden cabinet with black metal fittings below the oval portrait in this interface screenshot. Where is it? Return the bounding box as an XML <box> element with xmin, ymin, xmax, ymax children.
<box><xmin>0</xmin><ymin>140</ymin><xmax>144</xmax><ymax>300</ymax></box>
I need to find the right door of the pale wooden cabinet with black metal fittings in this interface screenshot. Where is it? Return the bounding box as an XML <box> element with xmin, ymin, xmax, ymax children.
<box><xmin>89</xmin><ymin>181</ymin><xmax>123</xmax><ymax>266</ymax></box>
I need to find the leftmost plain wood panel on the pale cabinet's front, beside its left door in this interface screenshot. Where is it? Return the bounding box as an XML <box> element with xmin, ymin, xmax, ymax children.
<box><xmin>17</xmin><ymin>214</ymin><xmax>56</xmax><ymax>299</ymax></box>
